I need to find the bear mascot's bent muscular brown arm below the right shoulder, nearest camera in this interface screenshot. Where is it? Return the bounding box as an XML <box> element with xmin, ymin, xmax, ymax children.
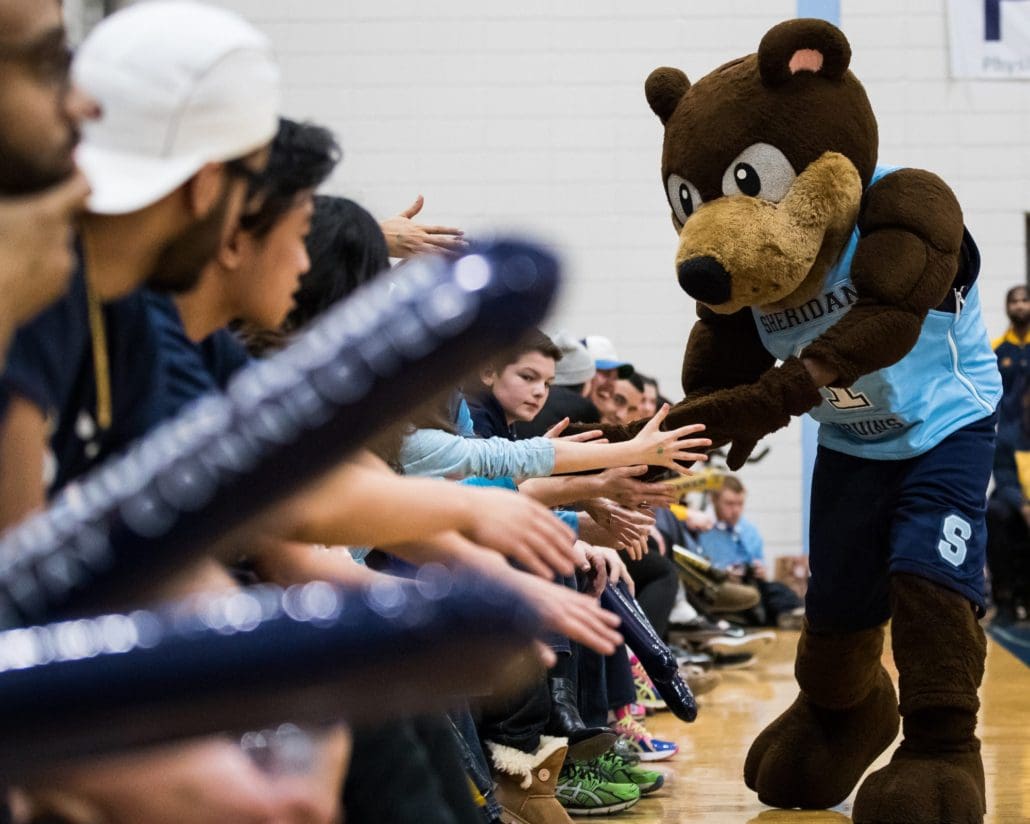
<box><xmin>803</xmin><ymin>169</ymin><xmax>963</xmax><ymax>386</ymax></box>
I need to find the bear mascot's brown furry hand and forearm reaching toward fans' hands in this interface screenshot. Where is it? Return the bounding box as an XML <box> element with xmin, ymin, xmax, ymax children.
<box><xmin>666</xmin><ymin>357</ymin><xmax>823</xmax><ymax>470</ymax></box>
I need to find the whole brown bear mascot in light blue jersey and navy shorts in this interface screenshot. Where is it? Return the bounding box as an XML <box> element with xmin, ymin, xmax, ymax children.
<box><xmin>646</xmin><ymin>20</ymin><xmax>1000</xmax><ymax>824</ymax></box>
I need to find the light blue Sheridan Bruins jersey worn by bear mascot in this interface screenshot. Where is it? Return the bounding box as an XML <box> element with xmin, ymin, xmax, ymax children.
<box><xmin>753</xmin><ymin>167</ymin><xmax>1001</xmax><ymax>460</ymax></box>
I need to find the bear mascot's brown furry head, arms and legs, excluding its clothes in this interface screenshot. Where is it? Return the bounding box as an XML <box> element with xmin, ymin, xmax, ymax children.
<box><xmin>634</xmin><ymin>21</ymin><xmax>985</xmax><ymax>824</ymax></box>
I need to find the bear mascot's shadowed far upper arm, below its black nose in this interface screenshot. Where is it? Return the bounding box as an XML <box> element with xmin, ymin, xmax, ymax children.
<box><xmin>668</xmin><ymin>304</ymin><xmax>775</xmax><ymax>401</ymax></box>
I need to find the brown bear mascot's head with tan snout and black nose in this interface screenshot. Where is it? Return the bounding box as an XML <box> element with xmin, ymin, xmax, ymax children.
<box><xmin>646</xmin><ymin>20</ymin><xmax>878</xmax><ymax>314</ymax></box>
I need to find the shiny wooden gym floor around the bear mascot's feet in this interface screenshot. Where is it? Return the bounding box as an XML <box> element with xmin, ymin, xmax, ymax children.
<box><xmin>609</xmin><ymin>632</ymin><xmax>1030</xmax><ymax>824</ymax></box>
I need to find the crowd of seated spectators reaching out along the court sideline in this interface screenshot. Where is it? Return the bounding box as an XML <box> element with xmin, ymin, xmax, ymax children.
<box><xmin>0</xmin><ymin>0</ymin><xmax>795</xmax><ymax>824</ymax></box>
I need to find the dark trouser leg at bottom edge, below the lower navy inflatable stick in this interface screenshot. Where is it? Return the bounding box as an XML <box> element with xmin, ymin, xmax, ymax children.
<box><xmin>343</xmin><ymin>716</ymin><xmax>482</xmax><ymax>824</ymax></box>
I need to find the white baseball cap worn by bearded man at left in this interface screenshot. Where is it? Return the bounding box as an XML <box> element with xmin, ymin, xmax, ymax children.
<box><xmin>72</xmin><ymin>0</ymin><xmax>280</xmax><ymax>214</ymax></box>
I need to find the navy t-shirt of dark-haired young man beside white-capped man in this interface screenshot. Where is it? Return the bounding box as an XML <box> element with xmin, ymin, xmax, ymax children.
<box><xmin>146</xmin><ymin>291</ymin><xmax>250</xmax><ymax>421</ymax></box>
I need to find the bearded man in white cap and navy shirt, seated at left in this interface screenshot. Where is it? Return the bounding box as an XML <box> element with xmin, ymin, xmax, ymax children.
<box><xmin>0</xmin><ymin>4</ymin><xmax>279</xmax><ymax>525</ymax></box>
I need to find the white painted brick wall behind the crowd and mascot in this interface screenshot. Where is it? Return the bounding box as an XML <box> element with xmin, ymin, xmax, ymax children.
<box><xmin>191</xmin><ymin>0</ymin><xmax>1030</xmax><ymax>555</ymax></box>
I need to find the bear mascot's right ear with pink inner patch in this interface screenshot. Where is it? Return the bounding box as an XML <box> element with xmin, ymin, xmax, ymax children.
<box><xmin>758</xmin><ymin>19</ymin><xmax>851</xmax><ymax>87</ymax></box>
